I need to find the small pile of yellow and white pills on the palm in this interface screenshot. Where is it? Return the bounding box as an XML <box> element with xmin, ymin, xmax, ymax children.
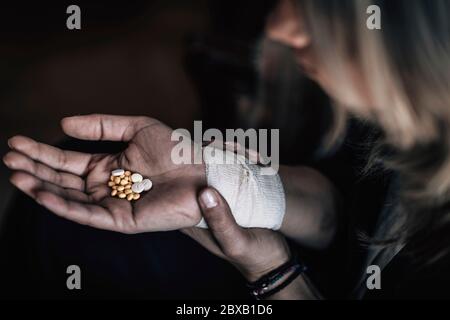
<box><xmin>108</xmin><ymin>169</ymin><xmax>153</xmax><ymax>201</ymax></box>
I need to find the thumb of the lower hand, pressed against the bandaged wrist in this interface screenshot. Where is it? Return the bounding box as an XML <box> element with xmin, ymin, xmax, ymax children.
<box><xmin>199</xmin><ymin>187</ymin><xmax>248</xmax><ymax>257</ymax></box>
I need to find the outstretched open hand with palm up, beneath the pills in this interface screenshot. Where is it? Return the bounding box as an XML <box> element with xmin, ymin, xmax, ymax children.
<box><xmin>4</xmin><ymin>115</ymin><xmax>206</xmax><ymax>233</ymax></box>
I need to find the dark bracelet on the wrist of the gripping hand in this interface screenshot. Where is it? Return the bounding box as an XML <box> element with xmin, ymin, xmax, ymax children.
<box><xmin>247</xmin><ymin>257</ymin><xmax>307</xmax><ymax>300</ymax></box>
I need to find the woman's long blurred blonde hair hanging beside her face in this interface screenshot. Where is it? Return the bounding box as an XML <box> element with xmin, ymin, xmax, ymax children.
<box><xmin>298</xmin><ymin>0</ymin><xmax>450</xmax><ymax>261</ymax></box>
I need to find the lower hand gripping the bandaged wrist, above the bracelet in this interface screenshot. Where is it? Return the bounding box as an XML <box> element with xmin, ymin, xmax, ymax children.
<box><xmin>182</xmin><ymin>187</ymin><xmax>291</xmax><ymax>281</ymax></box>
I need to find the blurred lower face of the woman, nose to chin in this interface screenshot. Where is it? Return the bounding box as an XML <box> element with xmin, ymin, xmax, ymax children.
<box><xmin>266</xmin><ymin>0</ymin><xmax>371</xmax><ymax>114</ymax></box>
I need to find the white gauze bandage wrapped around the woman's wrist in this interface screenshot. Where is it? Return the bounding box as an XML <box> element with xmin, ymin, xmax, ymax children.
<box><xmin>197</xmin><ymin>146</ymin><xmax>286</xmax><ymax>230</ymax></box>
